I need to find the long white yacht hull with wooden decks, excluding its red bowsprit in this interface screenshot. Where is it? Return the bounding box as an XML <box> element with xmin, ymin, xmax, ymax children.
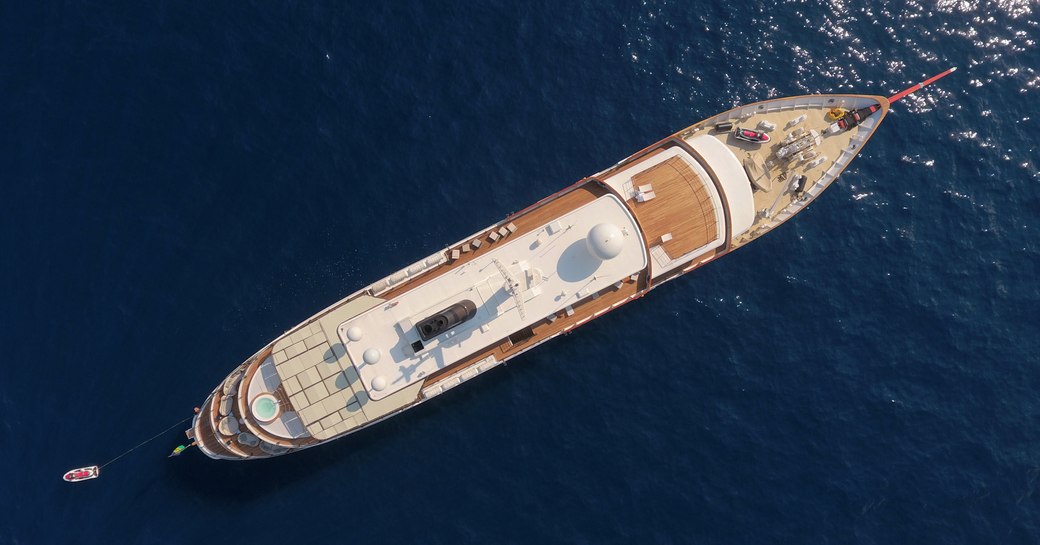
<box><xmin>189</xmin><ymin>95</ymin><xmax>888</xmax><ymax>460</ymax></box>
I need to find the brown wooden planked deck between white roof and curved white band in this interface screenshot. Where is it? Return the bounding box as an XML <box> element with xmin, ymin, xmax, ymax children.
<box><xmin>627</xmin><ymin>154</ymin><xmax>719</xmax><ymax>258</ymax></box>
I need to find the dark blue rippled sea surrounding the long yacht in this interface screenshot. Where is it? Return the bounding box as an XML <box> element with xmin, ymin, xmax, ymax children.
<box><xmin>0</xmin><ymin>0</ymin><xmax>1040</xmax><ymax>545</ymax></box>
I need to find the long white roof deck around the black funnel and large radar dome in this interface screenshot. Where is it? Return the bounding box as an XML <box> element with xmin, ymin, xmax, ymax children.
<box><xmin>338</xmin><ymin>196</ymin><xmax>647</xmax><ymax>399</ymax></box>
